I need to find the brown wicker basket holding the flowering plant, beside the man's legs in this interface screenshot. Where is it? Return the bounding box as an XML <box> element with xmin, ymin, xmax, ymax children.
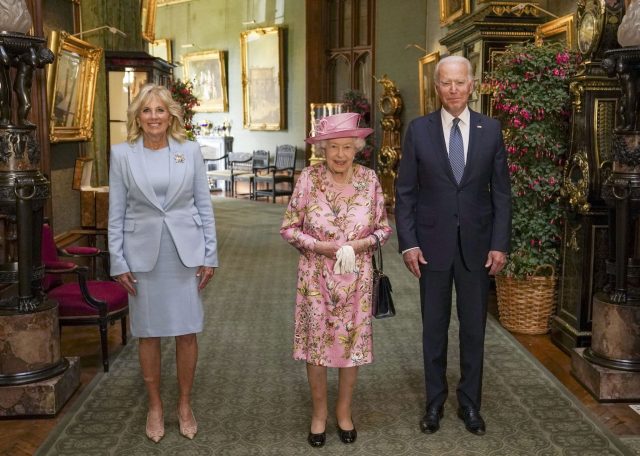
<box><xmin>496</xmin><ymin>266</ymin><xmax>558</xmax><ymax>334</ymax></box>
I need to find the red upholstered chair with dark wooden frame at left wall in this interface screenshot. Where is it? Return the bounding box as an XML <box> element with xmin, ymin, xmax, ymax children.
<box><xmin>42</xmin><ymin>224</ymin><xmax>129</xmax><ymax>372</ymax></box>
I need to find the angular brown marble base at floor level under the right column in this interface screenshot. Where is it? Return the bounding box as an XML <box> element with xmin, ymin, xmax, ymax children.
<box><xmin>571</xmin><ymin>348</ymin><xmax>640</xmax><ymax>402</ymax></box>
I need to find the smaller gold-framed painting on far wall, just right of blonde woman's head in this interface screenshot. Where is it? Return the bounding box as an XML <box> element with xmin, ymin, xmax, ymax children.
<box><xmin>182</xmin><ymin>50</ymin><xmax>229</xmax><ymax>112</ymax></box>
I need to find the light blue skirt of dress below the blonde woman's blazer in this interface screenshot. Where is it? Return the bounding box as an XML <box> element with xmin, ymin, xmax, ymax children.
<box><xmin>129</xmin><ymin>224</ymin><xmax>203</xmax><ymax>337</ymax></box>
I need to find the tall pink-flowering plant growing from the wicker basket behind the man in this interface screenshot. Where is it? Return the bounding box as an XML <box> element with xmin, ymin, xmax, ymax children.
<box><xmin>482</xmin><ymin>43</ymin><xmax>579</xmax><ymax>278</ymax></box>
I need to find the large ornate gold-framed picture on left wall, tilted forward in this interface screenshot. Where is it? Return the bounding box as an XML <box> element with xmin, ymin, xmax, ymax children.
<box><xmin>47</xmin><ymin>31</ymin><xmax>102</xmax><ymax>143</ymax></box>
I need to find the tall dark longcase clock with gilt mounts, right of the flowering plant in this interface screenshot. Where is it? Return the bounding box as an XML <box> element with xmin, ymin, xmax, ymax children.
<box><xmin>551</xmin><ymin>0</ymin><xmax>624</xmax><ymax>353</ymax></box>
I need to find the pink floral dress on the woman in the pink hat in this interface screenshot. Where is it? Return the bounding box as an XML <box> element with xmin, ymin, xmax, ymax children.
<box><xmin>280</xmin><ymin>164</ymin><xmax>391</xmax><ymax>367</ymax></box>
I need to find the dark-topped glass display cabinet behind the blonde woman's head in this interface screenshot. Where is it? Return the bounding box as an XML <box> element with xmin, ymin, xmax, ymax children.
<box><xmin>105</xmin><ymin>51</ymin><xmax>174</xmax><ymax>148</ymax></box>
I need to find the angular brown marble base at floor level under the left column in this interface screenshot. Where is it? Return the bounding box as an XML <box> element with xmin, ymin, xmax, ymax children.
<box><xmin>0</xmin><ymin>357</ymin><xmax>80</xmax><ymax>417</ymax></box>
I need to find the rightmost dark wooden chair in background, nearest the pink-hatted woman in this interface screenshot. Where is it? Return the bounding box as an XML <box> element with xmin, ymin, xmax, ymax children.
<box><xmin>253</xmin><ymin>144</ymin><xmax>297</xmax><ymax>203</ymax></box>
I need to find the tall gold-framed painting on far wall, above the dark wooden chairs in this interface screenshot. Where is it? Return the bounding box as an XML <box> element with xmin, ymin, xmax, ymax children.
<box><xmin>240</xmin><ymin>27</ymin><xmax>286</xmax><ymax>130</ymax></box>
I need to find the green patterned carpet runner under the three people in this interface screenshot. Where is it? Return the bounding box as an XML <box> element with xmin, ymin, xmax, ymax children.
<box><xmin>37</xmin><ymin>199</ymin><xmax>638</xmax><ymax>456</ymax></box>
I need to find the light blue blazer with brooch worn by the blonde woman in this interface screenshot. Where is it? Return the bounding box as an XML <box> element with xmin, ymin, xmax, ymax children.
<box><xmin>109</xmin><ymin>137</ymin><xmax>218</xmax><ymax>276</ymax></box>
